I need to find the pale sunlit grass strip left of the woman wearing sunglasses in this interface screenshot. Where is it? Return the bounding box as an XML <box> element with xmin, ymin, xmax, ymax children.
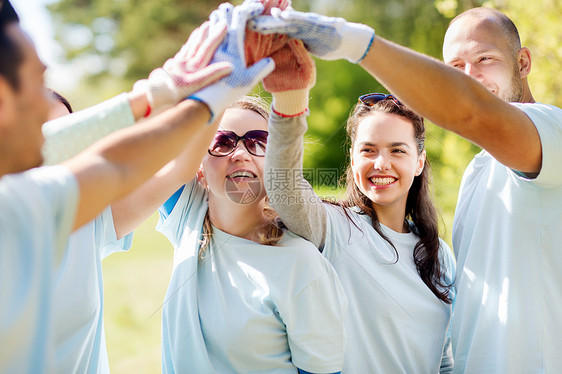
<box><xmin>103</xmin><ymin>214</ymin><xmax>173</xmax><ymax>374</ymax></box>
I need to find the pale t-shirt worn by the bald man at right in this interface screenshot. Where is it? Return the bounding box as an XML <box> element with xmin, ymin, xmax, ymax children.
<box><xmin>452</xmin><ymin>104</ymin><xmax>562</xmax><ymax>373</ymax></box>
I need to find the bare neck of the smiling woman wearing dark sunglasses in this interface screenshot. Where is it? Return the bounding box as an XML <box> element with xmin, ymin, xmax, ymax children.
<box><xmin>209</xmin><ymin>196</ymin><xmax>266</xmax><ymax>241</ymax></box>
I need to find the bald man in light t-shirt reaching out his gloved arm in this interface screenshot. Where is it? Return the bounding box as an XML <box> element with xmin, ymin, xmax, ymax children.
<box><xmin>250</xmin><ymin>4</ymin><xmax>562</xmax><ymax>373</ymax></box>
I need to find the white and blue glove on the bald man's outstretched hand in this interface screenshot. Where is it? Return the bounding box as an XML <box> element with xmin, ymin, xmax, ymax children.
<box><xmin>248</xmin><ymin>8</ymin><xmax>375</xmax><ymax>63</ymax></box>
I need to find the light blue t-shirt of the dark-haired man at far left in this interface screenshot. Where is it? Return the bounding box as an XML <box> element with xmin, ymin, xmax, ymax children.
<box><xmin>0</xmin><ymin>166</ymin><xmax>78</xmax><ymax>373</ymax></box>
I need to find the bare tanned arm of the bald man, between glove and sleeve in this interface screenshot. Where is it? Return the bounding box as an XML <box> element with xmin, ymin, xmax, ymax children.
<box><xmin>360</xmin><ymin>37</ymin><xmax>541</xmax><ymax>172</ymax></box>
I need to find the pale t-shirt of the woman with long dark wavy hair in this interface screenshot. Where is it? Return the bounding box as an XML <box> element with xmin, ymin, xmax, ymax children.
<box><xmin>322</xmin><ymin>204</ymin><xmax>455</xmax><ymax>374</ymax></box>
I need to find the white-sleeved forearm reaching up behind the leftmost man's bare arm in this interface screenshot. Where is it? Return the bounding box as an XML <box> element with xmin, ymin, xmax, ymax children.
<box><xmin>42</xmin><ymin>92</ymin><xmax>148</xmax><ymax>165</ymax></box>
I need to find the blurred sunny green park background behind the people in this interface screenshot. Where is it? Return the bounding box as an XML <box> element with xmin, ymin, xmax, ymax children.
<box><xmin>14</xmin><ymin>0</ymin><xmax>562</xmax><ymax>374</ymax></box>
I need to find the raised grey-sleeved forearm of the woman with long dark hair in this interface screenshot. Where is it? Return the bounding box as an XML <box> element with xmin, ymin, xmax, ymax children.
<box><xmin>265</xmin><ymin>114</ymin><xmax>326</xmax><ymax>249</ymax></box>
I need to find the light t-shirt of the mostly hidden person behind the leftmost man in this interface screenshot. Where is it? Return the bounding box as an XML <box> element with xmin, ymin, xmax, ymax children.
<box><xmin>53</xmin><ymin>208</ymin><xmax>133</xmax><ymax>373</ymax></box>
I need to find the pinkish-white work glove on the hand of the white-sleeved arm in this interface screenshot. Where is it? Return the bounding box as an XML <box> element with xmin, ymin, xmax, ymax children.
<box><xmin>133</xmin><ymin>20</ymin><xmax>232</xmax><ymax>113</ymax></box>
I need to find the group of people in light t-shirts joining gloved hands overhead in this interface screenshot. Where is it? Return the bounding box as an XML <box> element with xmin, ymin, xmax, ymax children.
<box><xmin>0</xmin><ymin>0</ymin><xmax>562</xmax><ymax>373</ymax></box>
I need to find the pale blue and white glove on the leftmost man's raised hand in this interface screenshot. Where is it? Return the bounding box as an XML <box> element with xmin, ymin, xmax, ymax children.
<box><xmin>190</xmin><ymin>2</ymin><xmax>275</xmax><ymax>116</ymax></box>
